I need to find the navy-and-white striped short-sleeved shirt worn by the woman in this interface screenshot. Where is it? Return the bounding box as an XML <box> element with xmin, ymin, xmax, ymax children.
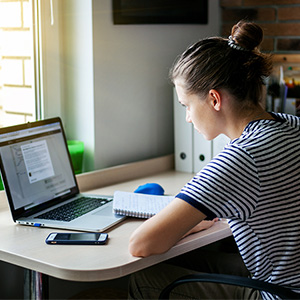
<box><xmin>177</xmin><ymin>114</ymin><xmax>300</xmax><ymax>299</ymax></box>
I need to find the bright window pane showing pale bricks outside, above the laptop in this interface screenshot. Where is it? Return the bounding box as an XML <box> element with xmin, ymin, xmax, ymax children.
<box><xmin>0</xmin><ymin>0</ymin><xmax>36</xmax><ymax>127</ymax></box>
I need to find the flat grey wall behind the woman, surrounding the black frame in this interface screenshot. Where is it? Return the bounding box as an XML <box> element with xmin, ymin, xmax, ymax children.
<box><xmin>93</xmin><ymin>0</ymin><xmax>219</xmax><ymax>169</ymax></box>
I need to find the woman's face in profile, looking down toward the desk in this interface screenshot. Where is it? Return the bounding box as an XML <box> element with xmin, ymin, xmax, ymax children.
<box><xmin>175</xmin><ymin>81</ymin><xmax>219</xmax><ymax>140</ymax></box>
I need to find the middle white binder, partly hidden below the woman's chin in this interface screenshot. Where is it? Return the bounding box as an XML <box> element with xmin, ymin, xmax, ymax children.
<box><xmin>193</xmin><ymin>129</ymin><xmax>212</xmax><ymax>173</ymax></box>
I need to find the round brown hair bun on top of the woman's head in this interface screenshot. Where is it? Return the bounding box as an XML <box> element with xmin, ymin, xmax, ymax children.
<box><xmin>231</xmin><ymin>21</ymin><xmax>264</xmax><ymax>50</ymax></box>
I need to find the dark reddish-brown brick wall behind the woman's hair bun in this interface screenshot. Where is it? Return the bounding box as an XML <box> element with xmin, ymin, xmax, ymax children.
<box><xmin>220</xmin><ymin>0</ymin><xmax>300</xmax><ymax>54</ymax></box>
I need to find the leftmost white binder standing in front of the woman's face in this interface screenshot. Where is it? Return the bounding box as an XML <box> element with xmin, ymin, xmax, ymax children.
<box><xmin>173</xmin><ymin>89</ymin><xmax>194</xmax><ymax>173</ymax></box>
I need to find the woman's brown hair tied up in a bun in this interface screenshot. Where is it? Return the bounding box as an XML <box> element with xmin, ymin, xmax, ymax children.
<box><xmin>170</xmin><ymin>21</ymin><xmax>272</xmax><ymax>104</ymax></box>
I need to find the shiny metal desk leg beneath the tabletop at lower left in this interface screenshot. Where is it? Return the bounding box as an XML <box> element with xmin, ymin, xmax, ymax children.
<box><xmin>24</xmin><ymin>269</ymin><xmax>49</xmax><ymax>300</ymax></box>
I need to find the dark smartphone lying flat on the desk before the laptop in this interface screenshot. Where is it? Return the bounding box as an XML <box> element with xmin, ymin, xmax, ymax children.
<box><xmin>46</xmin><ymin>232</ymin><xmax>108</xmax><ymax>245</ymax></box>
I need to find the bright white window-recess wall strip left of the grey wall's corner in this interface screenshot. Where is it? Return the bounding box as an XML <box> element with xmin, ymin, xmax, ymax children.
<box><xmin>60</xmin><ymin>0</ymin><xmax>95</xmax><ymax>171</ymax></box>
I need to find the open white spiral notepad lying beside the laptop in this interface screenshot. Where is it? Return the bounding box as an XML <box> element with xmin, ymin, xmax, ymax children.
<box><xmin>113</xmin><ymin>191</ymin><xmax>174</xmax><ymax>218</ymax></box>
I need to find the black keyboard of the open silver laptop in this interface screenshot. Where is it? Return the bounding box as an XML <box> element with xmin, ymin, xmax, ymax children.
<box><xmin>36</xmin><ymin>197</ymin><xmax>112</xmax><ymax>222</ymax></box>
